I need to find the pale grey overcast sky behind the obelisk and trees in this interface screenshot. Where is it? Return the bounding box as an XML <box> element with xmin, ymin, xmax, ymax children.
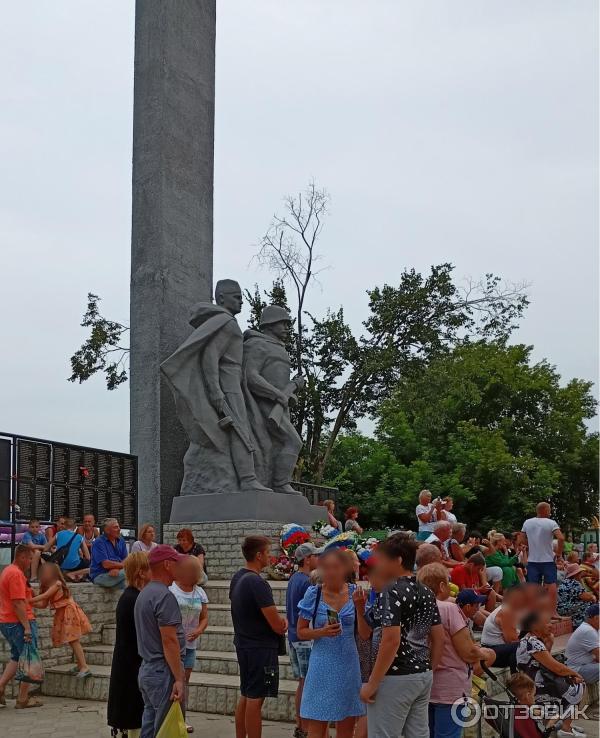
<box><xmin>0</xmin><ymin>0</ymin><xmax>598</xmax><ymax>450</ymax></box>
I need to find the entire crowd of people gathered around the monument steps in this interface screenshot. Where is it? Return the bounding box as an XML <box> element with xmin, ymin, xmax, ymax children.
<box><xmin>0</xmin><ymin>491</ymin><xmax>600</xmax><ymax>738</ymax></box>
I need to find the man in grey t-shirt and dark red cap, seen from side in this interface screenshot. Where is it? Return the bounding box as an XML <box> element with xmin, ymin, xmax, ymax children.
<box><xmin>134</xmin><ymin>545</ymin><xmax>187</xmax><ymax>738</ymax></box>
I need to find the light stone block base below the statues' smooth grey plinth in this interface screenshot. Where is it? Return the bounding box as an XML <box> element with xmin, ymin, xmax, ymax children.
<box><xmin>163</xmin><ymin>520</ymin><xmax>284</xmax><ymax>579</ymax></box>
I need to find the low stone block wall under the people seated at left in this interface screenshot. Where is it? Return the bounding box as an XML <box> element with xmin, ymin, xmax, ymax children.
<box><xmin>0</xmin><ymin>584</ymin><xmax>121</xmax><ymax>667</ymax></box>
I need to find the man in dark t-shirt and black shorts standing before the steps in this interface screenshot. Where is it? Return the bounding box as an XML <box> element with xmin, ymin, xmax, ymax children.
<box><xmin>229</xmin><ymin>536</ymin><xmax>287</xmax><ymax>738</ymax></box>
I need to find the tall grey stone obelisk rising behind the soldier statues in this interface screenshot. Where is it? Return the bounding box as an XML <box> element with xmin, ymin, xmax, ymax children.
<box><xmin>130</xmin><ymin>0</ymin><xmax>216</xmax><ymax>525</ymax></box>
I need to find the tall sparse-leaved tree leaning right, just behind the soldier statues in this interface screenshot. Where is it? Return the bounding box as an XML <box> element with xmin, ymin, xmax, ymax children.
<box><xmin>305</xmin><ymin>264</ymin><xmax>528</xmax><ymax>481</ymax></box>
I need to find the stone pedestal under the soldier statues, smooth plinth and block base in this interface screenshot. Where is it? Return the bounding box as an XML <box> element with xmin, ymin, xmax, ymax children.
<box><xmin>163</xmin><ymin>492</ymin><xmax>327</xmax><ymax>580</ymax></box>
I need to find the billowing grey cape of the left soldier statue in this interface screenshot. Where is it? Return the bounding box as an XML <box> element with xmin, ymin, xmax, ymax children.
<box><xmin>160</xmin><ymin>302</ymin><xmax>235</xmax><ymax>448</ymax></box>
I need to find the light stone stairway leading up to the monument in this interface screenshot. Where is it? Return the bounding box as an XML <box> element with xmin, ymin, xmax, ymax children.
<box><xmin>42</xmin><ymin>581</ymin><xmax>296</xmax><ymax>721</ymax></box>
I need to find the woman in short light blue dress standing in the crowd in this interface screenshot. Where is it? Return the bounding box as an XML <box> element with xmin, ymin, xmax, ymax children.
<box><xmin>297</xmin><ymin>549</ymin><xmax>365</xmax><ymax>738</ymax></box>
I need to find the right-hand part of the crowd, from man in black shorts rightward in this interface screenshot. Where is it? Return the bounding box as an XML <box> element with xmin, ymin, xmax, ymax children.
<box><xmin>238</xmin><ymin>506</ymin><xmax>600</xmax><ymax>738</ymax></box>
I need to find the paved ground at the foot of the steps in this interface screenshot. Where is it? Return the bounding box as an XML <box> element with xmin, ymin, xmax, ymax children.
<box><xmin>0</xmin><ymin>697</ymin><xmax>293</xmax><ymax>738</ymax></box>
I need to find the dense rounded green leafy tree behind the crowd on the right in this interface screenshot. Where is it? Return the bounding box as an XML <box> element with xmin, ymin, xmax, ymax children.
<box><xmin>325</xmin><ymin>341</ymin><xmax>598</xmax><ymax>530</ymax></box>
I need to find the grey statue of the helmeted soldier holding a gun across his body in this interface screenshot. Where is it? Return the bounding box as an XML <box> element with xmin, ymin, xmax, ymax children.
<box><xmin>242</xmin><ymin>305</ymin><xmax>304</xmax><ymax>494</ymax></box>
